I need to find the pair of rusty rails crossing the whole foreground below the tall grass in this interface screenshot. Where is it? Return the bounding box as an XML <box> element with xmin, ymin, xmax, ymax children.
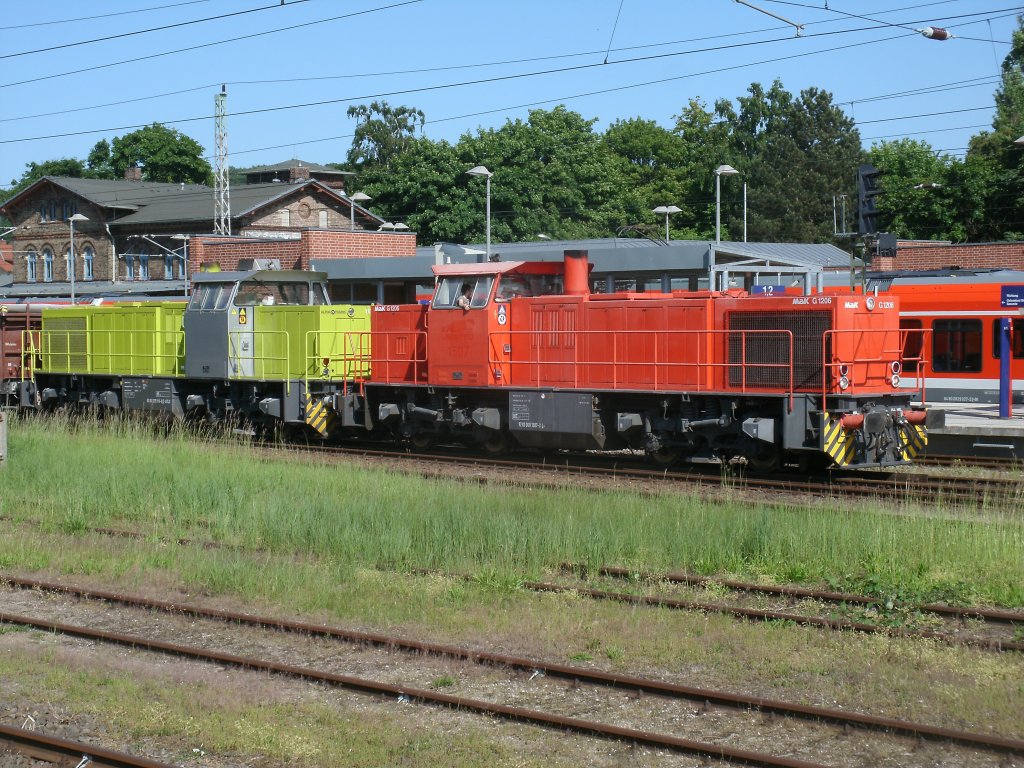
<box><xmin>0</xmin><ymin>580</ymin><xmax>1024</xmax><ymax>768</ymax></box>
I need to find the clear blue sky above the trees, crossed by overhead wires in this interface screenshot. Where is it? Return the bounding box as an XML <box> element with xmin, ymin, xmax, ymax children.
<box><xmin>0</xmin><ymin>0</ymin><xmax>1024</xmax><ymax>185</ymax></box>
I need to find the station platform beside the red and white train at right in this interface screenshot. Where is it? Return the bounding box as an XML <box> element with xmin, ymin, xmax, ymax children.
<box><xmin>928</xmin><ymin>402</ymin><xmax>1024</xmax><ymax>461</ymax></box>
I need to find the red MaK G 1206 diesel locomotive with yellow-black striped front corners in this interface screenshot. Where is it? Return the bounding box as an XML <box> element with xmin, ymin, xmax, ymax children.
<box><xmin>359</xmin><ymin>252</ymin><xmax>927</xmax><ymax>470</ymax></box>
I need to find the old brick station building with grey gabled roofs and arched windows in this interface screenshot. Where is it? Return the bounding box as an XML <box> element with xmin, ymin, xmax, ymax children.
<box><xmin>0</xmin><ymin>166</ymin><xmax>407</xmax><ymax>297</ymax></box>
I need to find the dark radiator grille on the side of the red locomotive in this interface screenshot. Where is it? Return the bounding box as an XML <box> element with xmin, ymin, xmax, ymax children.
<box><xmin>727</xmin><ymin>311</ymin><xmax>831</xmax><ymax>390</ymax></box>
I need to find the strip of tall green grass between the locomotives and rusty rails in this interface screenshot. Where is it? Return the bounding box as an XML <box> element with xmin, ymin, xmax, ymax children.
<box><xmin>0</xmin><ymin>419</ymin><xmax>1024</xmax><ymax>606</ymax></box>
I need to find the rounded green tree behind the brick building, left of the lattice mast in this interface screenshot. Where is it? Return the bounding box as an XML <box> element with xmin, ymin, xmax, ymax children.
<box><xmin>107</xmin><ymin>123</ymin><xmax>213</xmax><ymax>184</ymax></box>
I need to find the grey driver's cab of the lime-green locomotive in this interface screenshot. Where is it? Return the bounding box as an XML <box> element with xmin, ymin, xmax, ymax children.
<box><xmin>184</xmin><ymin>269</ymin><xmax>331</xmax><ymax>380</ymax></box>
